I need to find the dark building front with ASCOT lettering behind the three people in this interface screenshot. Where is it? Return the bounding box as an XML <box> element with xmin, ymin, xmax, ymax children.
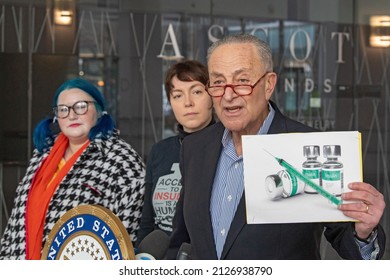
<box><xmin>0</xmin><ymin>0</ymin><xmax>390</xmax><ymax>259</ymax></box>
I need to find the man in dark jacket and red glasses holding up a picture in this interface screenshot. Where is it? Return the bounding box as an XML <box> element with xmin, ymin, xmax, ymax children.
<box><xmin>168</xmin><ymin>34</ymin><xmax>385</xmax><ymax>259</ymax></box>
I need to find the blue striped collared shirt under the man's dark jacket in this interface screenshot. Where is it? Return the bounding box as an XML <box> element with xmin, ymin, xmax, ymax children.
<box><xmin>210</xmin><ymin>104</ymin><xmax>275</xmax><ymax>259</ymax></box>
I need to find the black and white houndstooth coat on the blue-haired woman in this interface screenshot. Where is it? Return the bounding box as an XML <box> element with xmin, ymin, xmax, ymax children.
<box><xmin>0</xmin><ymin>132</ymin><xmax>145</xmax><ymax>259</ymax></box>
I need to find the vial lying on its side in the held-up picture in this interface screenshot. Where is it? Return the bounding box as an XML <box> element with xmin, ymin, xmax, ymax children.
<box><xmin>265</xmin><ymin>170</ymin><xmax>304</xmax><ymax>200</ymax></box>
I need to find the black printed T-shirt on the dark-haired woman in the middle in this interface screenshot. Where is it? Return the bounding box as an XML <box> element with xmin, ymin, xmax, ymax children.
<box><xmin>137</xmin><ymin>119</ymin><xmax>215</xmax><ymax>244</ymax></box>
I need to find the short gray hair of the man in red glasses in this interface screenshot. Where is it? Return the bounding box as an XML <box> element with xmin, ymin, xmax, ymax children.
<box><xmin>207</xmin><ymin>33</ymin><xmax>273</xmax><ymax>72</ymax></box>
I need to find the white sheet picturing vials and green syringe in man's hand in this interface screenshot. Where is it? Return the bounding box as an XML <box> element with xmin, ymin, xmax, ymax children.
<box><xmin>242</xmin><ymin>131</ymin><xmax>363</xmax><ymax>224</ymax></box>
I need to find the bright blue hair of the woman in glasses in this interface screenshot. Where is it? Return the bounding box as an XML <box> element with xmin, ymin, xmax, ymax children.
<box><xmin>33</xmin><ymin>78</ymin><xmax>115</xmax><ymax>152</ymax></box>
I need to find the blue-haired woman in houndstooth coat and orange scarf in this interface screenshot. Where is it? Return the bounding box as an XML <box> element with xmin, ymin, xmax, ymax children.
<box><xmin>0</xmin><ymin>78</ymin><xmax>145</xmax><ymax>259</ymax></box>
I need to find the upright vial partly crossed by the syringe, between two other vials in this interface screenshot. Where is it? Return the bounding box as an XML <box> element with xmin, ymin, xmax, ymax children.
<box><xmin>302</xmin><ymin>146</ymin><xmax>322</xmax><ymax>193</ymax></box>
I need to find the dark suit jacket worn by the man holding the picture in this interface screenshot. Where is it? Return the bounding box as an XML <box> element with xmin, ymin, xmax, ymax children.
<box><xmin>167</xmin><ymin>102</ymin><xmax>385</xmax><ymax>260</ymax></box>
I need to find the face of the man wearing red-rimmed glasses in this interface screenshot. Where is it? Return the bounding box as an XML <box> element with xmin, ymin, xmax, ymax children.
<box><xmin>208</xmin><ymin>43</ymin><xmax>276</xmax><ymax>135</ymax></box>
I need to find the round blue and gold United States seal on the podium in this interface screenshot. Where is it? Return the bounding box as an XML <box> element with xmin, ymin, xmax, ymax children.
<box><xmin>41</xmin><ymin>205</ymin><xmax>135</xmax><ymax>260</ymax></box>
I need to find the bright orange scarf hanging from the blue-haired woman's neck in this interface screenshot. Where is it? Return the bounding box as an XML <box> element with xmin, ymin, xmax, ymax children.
<box><xmin>26</xmin><ymin>133</ymin><xmax>89</xmax><ymax>260</ymax></box>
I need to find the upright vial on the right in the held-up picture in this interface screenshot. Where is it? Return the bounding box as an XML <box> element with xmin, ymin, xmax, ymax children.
<box><xmin>321</xmin><ymin>145</ymin><xmax>344</xmax><ymax>196</ymax></box>
